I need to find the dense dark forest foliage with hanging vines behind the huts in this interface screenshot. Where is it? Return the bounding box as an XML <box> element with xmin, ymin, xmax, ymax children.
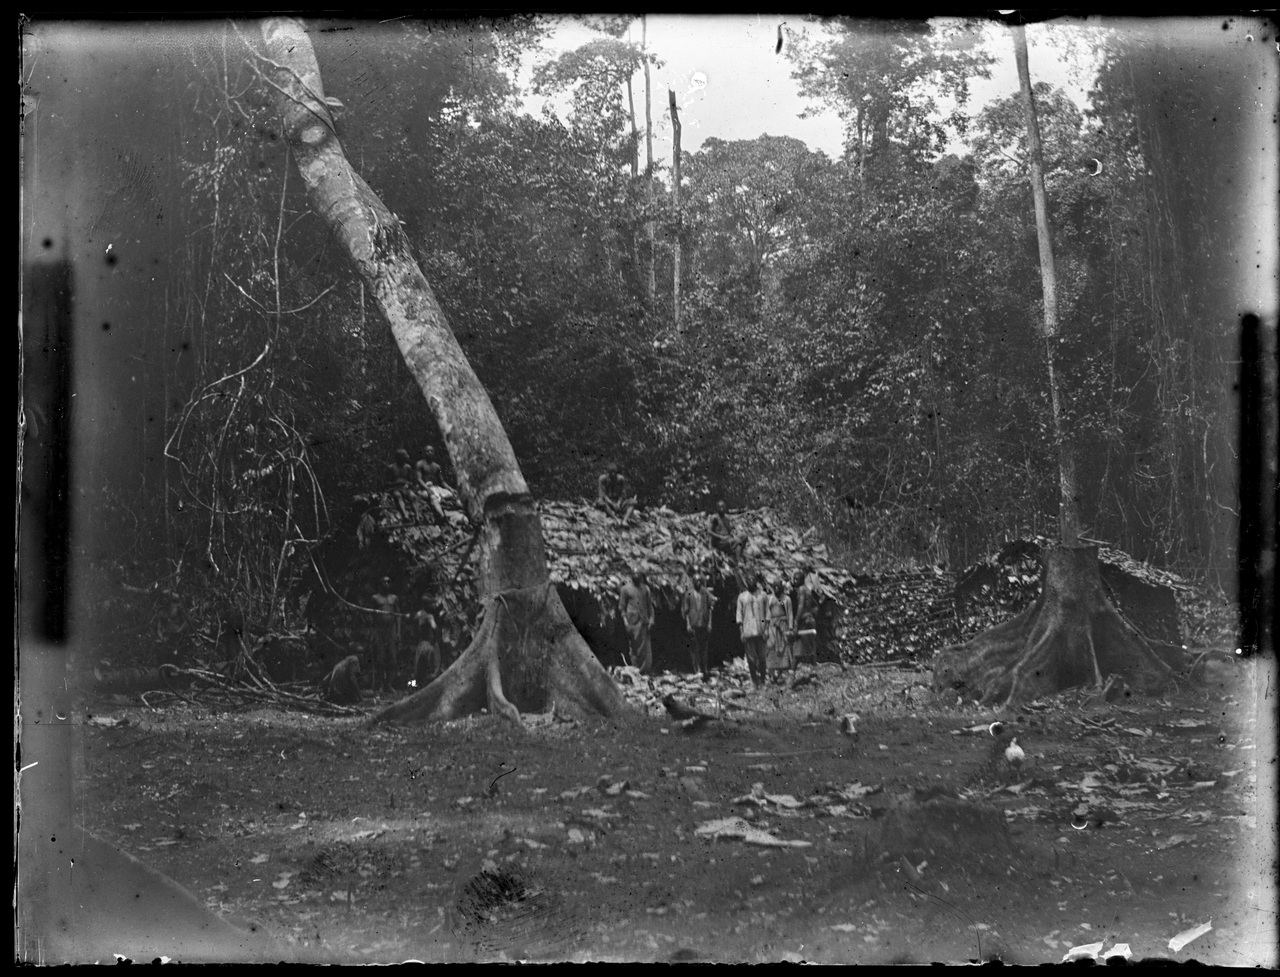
<box><xmin>24</xmin><ymin>17</ymin><xmax>1274</xmax><ymax>650</ymax></box>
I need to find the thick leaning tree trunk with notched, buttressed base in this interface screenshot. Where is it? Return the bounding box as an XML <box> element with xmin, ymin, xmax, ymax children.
<box><xmin>262</xmin><ymin>18</ymin><xmax>628</xmax><ymax>723</ymax></box>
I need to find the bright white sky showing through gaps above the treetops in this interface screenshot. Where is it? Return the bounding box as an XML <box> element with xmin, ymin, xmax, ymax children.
<box><xmin>522</xmin><ymin>14</ymin><xmax>1089</xmax><ymax>159</ymax></box>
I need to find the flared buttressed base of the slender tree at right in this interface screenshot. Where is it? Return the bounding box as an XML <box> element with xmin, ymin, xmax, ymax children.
<box><xmin>933</xmin><ymin>545</ymin><xmax>1174</xmax><ymax>707</ymax></box>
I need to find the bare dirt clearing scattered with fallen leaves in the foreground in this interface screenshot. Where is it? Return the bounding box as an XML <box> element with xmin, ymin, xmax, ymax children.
<box><xmin>77</xmin><ymin>661</ymin><xmax>1276</xmax><ymax>965</ymax></box>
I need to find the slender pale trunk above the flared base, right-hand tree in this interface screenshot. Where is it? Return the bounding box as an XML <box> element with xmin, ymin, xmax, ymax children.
<box><xmin>1012</xmin><ymin>24</ymin><xmax>1080</xmax><ymax>547</ymax></box>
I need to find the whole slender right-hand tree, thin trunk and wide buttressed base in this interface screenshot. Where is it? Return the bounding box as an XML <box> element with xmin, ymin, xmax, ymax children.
<box><xmin>933</xmin><ymin>26</ymin><xmax>1172</xmax><ymax>706</ymax></box>
